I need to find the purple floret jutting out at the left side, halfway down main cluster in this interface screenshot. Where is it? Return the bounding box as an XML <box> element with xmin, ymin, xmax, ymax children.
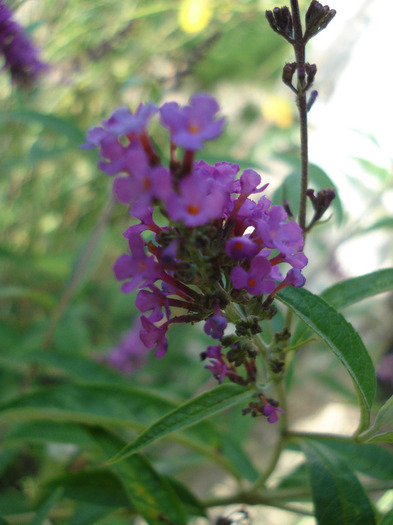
<box><xmin>113</xmin><ymin>233</ymin><xmax>160</xmax><ymax>293</ymax></box>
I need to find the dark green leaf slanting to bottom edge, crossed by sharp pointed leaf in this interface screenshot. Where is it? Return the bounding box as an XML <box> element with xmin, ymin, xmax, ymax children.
<box><xmin>92</xmin><ymin>429</ymin><xmax>187</xmax><ymax>525</ymax></box>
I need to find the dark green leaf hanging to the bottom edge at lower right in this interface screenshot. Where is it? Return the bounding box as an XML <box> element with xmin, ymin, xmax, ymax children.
<box><xmin>300</xmin><ymin>439</ymin><xmax>376</xmax><ymax>525</ymax></box>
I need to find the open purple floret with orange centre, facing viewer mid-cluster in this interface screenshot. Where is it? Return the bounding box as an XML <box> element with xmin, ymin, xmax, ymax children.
<box><xmin>166</xmin><ymin>175</ymin><xmax>225</xmax><ymax>227</ymax></box>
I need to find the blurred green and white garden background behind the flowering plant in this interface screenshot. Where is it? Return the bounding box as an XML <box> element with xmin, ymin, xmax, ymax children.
<box><xmin>0</xmin><ymin>0</ymin><xmax>393</xmax><ymax>525</ymax></box>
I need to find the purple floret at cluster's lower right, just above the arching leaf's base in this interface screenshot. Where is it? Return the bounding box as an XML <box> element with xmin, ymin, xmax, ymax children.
<box><xmin>231</xmin><ymin>255</ymin><xmax>275</xmax><ymax>295</ymax></box>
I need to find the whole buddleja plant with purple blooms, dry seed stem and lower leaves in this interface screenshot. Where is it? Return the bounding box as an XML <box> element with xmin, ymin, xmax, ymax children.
<box><xmin>0</xmin><ymin>0</ymin><xmax>393</xmax><ymax>525</ymax></box>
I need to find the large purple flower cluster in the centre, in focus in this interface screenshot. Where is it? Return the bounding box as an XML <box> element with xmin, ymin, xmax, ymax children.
<box><xmin>82</xmin><ymin>94</ymin><xmax>307</xmax><ymax>419</ymax></box>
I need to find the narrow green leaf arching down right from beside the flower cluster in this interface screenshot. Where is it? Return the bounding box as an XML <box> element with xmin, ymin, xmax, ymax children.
<box><xmin>278</xmin><ymin>286</ymin><xmax>376</xmax><ymax>432</ymax></box>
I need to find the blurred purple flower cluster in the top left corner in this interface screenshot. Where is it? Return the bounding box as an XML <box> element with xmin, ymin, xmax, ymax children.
<box><xmin>0</xmin><ymin>0</ymin><xmax>47</xmax><ymax>87</ymax></box>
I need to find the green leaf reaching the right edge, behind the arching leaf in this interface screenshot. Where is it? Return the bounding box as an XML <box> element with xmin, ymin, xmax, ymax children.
<box><xmin>321</xmin><ymin>268</ymin><xmax>393</xmax><ymax>309</ymax></box>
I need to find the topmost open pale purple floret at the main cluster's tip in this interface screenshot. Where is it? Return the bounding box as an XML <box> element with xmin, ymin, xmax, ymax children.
<box><xmin>160</xmin><ymin>94</ymin><xmax>225</xmax><ymax>151</ymax></box>
